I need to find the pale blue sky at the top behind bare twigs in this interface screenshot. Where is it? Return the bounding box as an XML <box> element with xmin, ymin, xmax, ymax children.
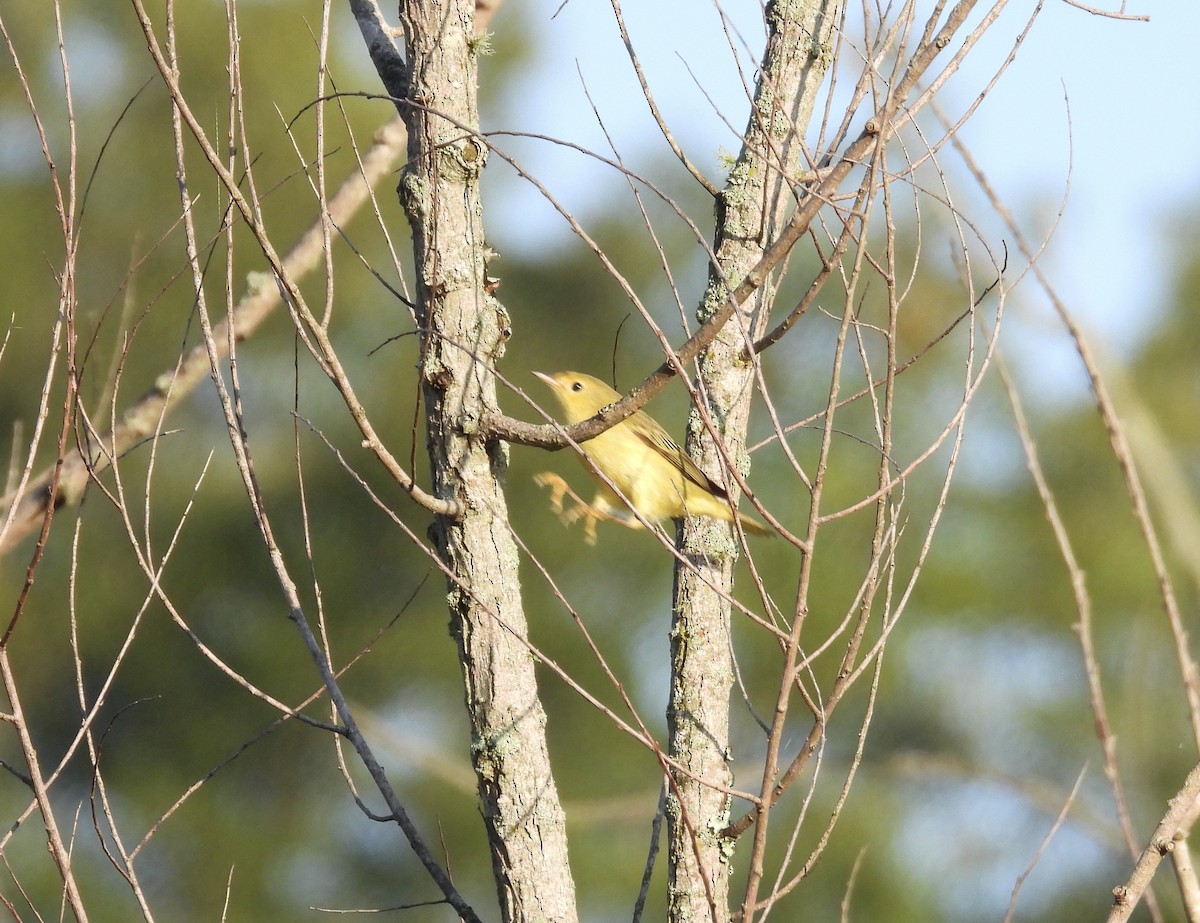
<box><xmin>485</xmin><ymin>0</ymin><xmax>1200</xmax><ymax>374</ymax></box>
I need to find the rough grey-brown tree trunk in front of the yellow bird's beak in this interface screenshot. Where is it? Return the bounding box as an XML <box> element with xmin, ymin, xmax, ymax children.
<box><xmin>400</xmin><ymin>0</ymin><xmax>577</xmax><ymax>923</ymax></box>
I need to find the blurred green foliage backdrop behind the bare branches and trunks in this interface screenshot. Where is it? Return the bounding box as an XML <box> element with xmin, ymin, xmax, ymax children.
<box><xmin>0</xmin><ymin>2</ymin><xmax>1200</xmax><ymax>921</ymax></box>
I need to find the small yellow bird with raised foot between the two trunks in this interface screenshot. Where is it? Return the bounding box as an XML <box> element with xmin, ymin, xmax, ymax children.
<box><xmin>534</xmin><ymin>372</ymin><xmax>772</xmax><ymax>541</ymax></box>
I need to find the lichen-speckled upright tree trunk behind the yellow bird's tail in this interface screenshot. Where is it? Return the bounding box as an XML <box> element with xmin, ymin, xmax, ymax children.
<box><xmin>667</xmin><ymin>0</ymin><xmax>839</xmax><ymax>923</ymax></box>
